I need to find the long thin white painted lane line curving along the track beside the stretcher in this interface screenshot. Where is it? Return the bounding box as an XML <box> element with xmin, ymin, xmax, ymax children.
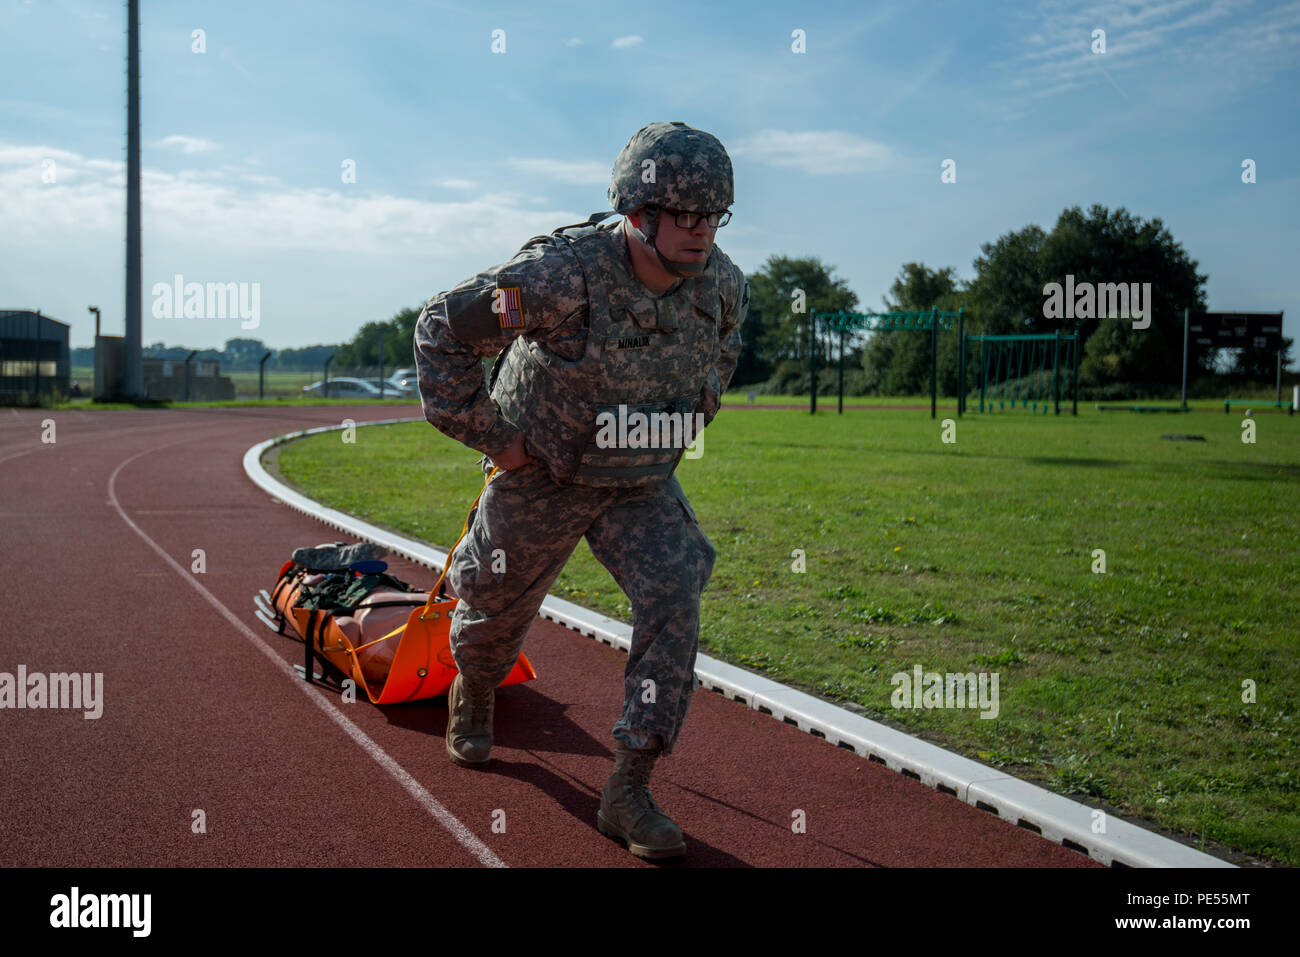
<box><xmin>108</xmin><ymin>438</ymin><xmax>508</xmax><ymax>867</ymax></box>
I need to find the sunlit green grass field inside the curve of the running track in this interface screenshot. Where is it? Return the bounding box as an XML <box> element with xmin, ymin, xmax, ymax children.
<box><xmin>280</xmin><ymin>395</ymin><xmax>1300</xmax><ymax>866</ymax></box>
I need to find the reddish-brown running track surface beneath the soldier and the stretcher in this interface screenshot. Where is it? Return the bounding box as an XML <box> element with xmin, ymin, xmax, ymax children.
<box><xmin>0</xmin><ymin>406</ymin><xmax>1097</xmax><ymax>867</ymax></box>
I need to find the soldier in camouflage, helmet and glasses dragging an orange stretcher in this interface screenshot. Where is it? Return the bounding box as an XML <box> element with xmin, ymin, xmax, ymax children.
<box><xmin>415</xmin><ymin>122</ymin><xmax>749</xmax><ymax>858</ymax></box>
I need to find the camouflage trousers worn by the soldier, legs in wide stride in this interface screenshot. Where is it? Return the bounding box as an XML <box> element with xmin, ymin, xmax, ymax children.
<box><xmin>447</xmin><ymin>463</ymin><xmax>714</xmax><ymax>752</ymax></box>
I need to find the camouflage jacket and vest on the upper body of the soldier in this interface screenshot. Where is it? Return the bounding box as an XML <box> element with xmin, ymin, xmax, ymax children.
<box><xmin>415</xmin><ymin>217</ymin><xmax>749</xmax><ymax>486</ymax></box>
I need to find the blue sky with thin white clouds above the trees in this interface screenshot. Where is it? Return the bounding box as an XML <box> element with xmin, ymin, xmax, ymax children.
<box><xmin>0</xmin><ymin>0</ymin><xmax>1300</xmax><ymax>348</ymax></box>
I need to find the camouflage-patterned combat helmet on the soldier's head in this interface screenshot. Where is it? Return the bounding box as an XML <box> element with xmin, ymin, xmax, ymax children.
<box><xmin>610</xmin><ymin>122</ymin><xmax>735</xmax><ymax>215</ymax></box>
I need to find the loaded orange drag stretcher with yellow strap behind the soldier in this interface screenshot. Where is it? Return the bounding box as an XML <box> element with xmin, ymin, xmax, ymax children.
<box><xmin>255</xmin><ymin>468</ymin><xmax>537</xmax><ymax>705</ymax></box>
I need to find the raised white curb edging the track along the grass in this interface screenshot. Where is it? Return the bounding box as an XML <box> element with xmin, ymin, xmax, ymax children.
<box><xmin>243</xmin><ymin>416</ymin><xmax>1234</xmax><ymax>867</ymax></box>
